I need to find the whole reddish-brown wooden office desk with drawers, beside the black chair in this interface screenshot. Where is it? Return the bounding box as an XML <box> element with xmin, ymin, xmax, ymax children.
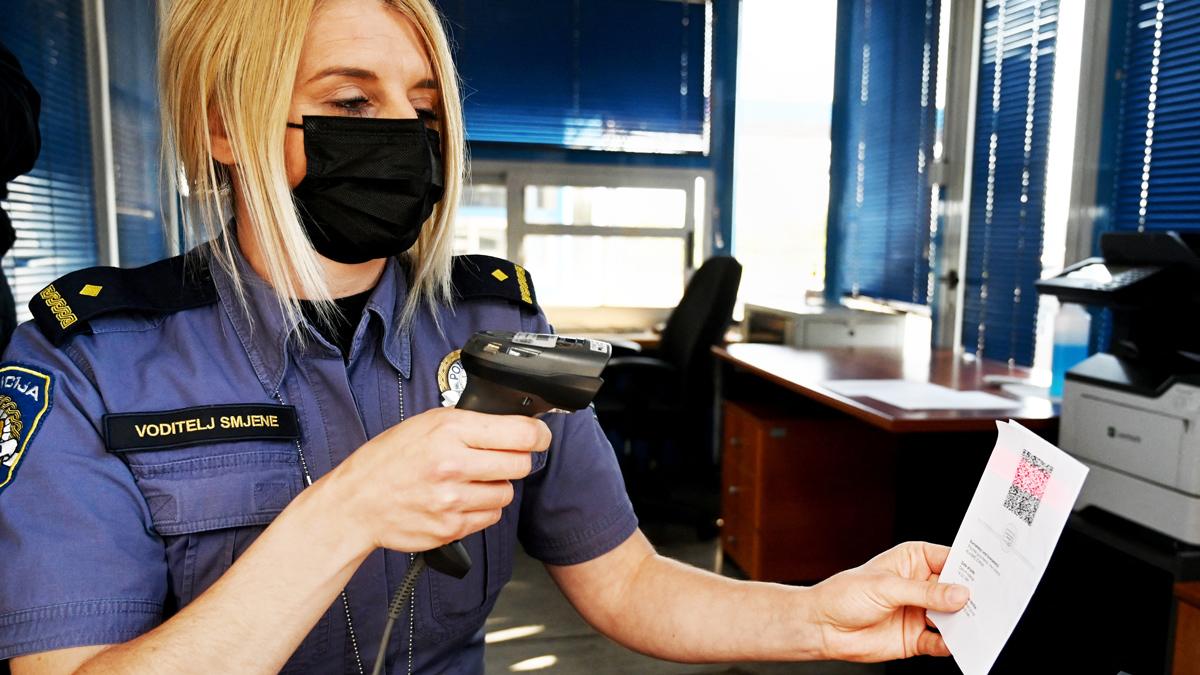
<box><xmin>713</xmin><ymin>344</ymin><xmax>1057</xmax><ymax>581</ymax></box>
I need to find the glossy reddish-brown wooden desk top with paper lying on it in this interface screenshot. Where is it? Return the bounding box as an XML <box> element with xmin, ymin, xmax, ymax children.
<box><xmin>713</xmin><ymin>344</ymin><xmax>1058</xmax><ymax>434</ymax></box>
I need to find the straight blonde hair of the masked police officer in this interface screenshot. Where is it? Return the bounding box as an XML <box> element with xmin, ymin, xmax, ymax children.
<box><xmin>160</xmin><ymin>0</ymin><xmax>467</xmax><ymax>323</ymax></box>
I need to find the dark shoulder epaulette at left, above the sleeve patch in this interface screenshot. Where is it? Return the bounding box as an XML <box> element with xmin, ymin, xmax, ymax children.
<box><xmin>29</xmin><ymin>253</ymin><xmax>217</xmax><ymax>345</ymax></box>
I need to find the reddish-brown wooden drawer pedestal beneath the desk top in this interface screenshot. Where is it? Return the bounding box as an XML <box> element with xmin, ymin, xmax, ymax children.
<box><xmin>721</xmin><ymin>402</ymin><xmax>895</xmax><ymax>581</ymax></box>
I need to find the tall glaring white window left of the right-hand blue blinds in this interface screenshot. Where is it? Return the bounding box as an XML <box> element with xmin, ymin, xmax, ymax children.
<box><xmin>733</xmin><ymin>0</ymin><xmax>838</xmax><ymax>305</ymax></box>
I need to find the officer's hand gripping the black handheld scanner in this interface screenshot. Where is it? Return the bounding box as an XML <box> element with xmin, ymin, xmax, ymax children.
<box><xmin>324</xmin><ymin>408</ymin><xmax>550</xmax><ymax>554</ymax></box>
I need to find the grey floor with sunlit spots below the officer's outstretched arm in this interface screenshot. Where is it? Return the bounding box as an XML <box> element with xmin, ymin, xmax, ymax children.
<box><xmin>486</xmin><ymin>527</ymin><xmax>883</xmax><ymax>675</ymax></box>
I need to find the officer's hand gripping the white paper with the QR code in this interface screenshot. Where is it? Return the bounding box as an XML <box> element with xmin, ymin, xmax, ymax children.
<box><xmin>812</xmin><ymin>542</ymin><xmax>968</xmax><ymax>661</ymax></box>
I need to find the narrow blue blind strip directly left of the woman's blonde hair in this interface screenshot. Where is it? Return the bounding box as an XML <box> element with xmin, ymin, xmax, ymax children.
<box><xmin>104</xmin><ymin>0</ymin><xmax>167</xmax><ymax>267</ymax></box>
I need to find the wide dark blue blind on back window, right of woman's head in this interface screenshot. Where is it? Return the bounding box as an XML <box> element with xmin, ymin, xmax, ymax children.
<box><xmin>438</xmin><ymin>0</ymin><xmax>712</xmax><ymax>153</ymax></box>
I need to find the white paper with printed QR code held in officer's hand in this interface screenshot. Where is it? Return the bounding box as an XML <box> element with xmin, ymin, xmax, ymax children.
<box><xmin>929</xmin><ymin>422</ymin><xmax>1087</xmax><ymax>675</ymax></box>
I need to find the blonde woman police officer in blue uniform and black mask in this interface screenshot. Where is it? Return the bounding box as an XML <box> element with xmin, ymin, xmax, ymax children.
<box><xmin>0</xmin><ymin>0</ymin><xmax>966</xmax><ymax>675</ymax></box>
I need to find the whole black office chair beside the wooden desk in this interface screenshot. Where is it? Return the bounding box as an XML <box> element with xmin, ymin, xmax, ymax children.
<box><xmin>595</xmin><ymin>256</ymin><xmax>742</xmax><ymax>537</ymax></box>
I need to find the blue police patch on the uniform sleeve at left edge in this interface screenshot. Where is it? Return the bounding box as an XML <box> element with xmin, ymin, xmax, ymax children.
<box><xmin>0</xmin><ymin>362</ymin><xmax>54</xmax><ymax>490</ymax></box>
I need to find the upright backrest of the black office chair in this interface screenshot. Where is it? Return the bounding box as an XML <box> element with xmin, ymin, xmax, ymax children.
<box><xmin>659</xmin><ymin>256</ymin><xmax>742</xmax><ymax>377</ymax></box>
